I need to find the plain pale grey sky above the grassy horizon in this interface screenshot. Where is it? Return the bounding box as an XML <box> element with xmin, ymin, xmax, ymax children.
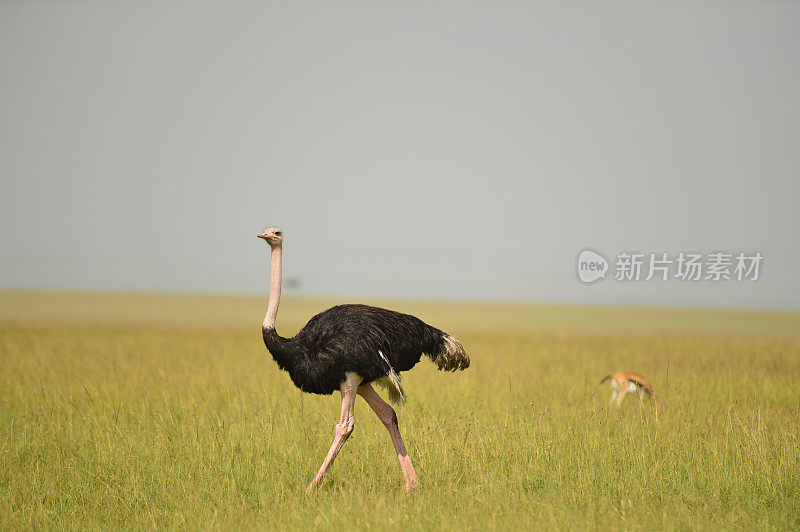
<box><xmin>0</xmin><ymin>0</ymin><xmax>800</xmax><ymax>308</ymax></box>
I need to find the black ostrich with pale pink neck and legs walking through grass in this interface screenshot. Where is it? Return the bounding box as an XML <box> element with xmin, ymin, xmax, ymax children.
<box><xmin>258</xmin><ymin>227</ymin><xmax>469</xmax><ymax>492</ymax></box>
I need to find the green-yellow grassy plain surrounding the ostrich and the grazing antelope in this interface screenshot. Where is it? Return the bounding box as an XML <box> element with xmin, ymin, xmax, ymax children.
<box><xmin>0</xmin><ymin>292</ymin><xmax>800</xmax><ymax>530</ymax></box>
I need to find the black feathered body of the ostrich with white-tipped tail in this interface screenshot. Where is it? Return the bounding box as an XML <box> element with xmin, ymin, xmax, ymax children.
<box><xmin>263</xmin><ymin>305</ymin><xmax>462</xmax><ymax>395</ymax></box>
